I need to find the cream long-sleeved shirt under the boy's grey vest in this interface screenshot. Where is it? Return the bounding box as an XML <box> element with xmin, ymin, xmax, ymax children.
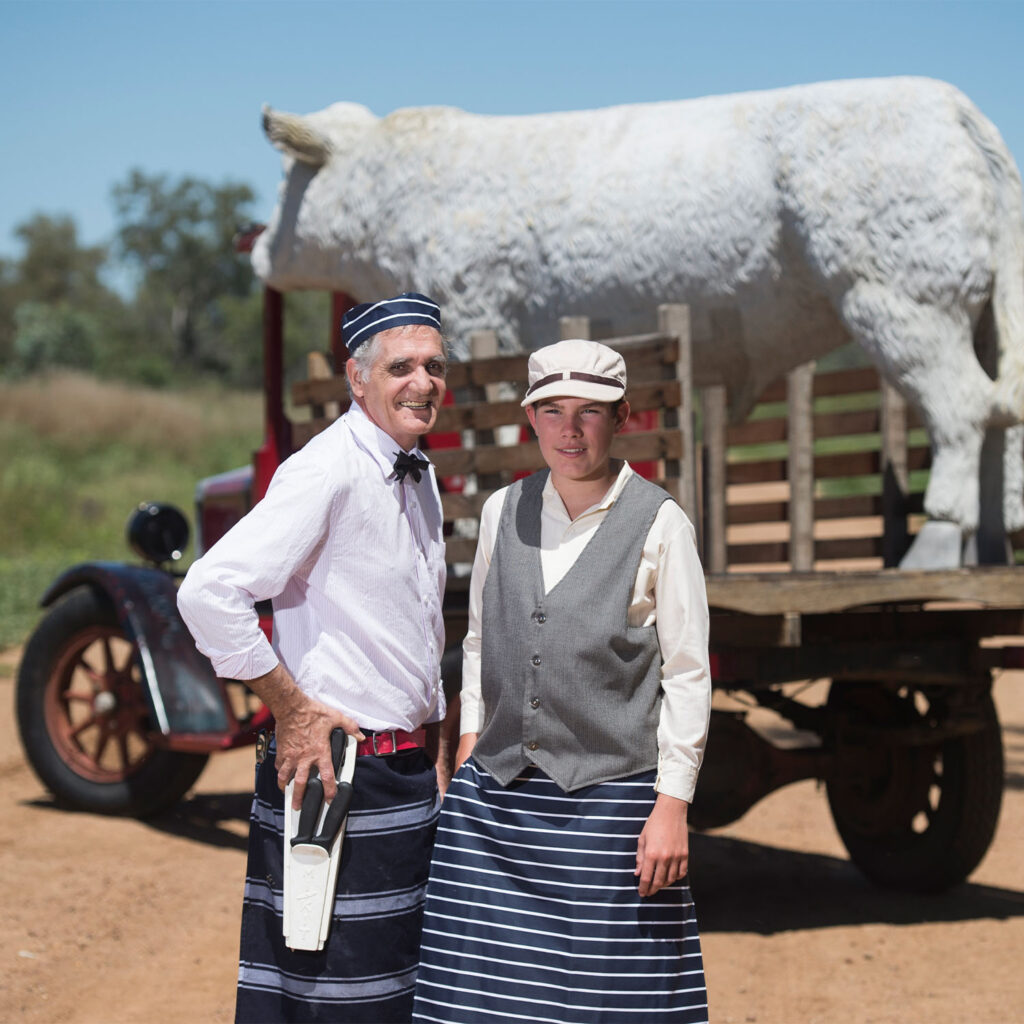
<box><xmin>460</xmin><ymin>463</ymin><xmax>711</xmax><ymax>801</ymax></box>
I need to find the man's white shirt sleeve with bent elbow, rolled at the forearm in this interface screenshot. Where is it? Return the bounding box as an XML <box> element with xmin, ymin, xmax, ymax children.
<box><xmin>178</xmin><ymin>460</ymin><xmax>332</xmax><ymax>680</ymax></box>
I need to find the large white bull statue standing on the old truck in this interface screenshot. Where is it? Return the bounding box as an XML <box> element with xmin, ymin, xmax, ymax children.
<box><xmin>253</xmin><ymin>78</ymin><xmax>1024</xmax><ymax>567</ymax></box>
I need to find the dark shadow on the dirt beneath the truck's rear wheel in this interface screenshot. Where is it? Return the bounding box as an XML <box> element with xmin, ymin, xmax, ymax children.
<box><xmin>690</xmin><ymin>834</ymin><xmax>1024</xmax><ymax>935</ymax></box>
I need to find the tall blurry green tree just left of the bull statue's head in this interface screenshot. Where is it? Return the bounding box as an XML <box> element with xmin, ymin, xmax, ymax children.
<box><xmin>114</xmin><ymin>169</ymin><xmax>255</xmax><ymax>376</ymax></box>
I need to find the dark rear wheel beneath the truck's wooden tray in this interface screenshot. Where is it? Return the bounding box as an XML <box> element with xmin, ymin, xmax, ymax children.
<box><xmin>826</xmin><ymin>682</ymin><xmax>1002</xmax><ymax>892</ymax></box>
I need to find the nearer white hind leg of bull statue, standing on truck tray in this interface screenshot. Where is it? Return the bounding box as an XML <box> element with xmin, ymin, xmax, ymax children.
<box><xmin>840</xmin><ymin>282</ymin><xmax>993</xmax><ymax>569</ymax></box>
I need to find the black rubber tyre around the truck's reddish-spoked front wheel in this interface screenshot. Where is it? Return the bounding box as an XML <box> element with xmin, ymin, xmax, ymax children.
<box><xmin>15</xmin><ymin>587</ymin><xmax>208</xmax><ymax>818</ymax></box>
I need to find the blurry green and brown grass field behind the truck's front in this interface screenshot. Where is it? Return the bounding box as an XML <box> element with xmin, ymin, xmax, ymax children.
<box><xmin>0</xmin><ymin>373</ymin><xmax>262</xmax><ymax>648</ymax></box>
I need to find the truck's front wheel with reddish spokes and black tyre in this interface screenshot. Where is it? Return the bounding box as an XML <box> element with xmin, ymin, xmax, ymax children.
<box><xmin>17</xmin><ymin>588</ymin><xmax>207</xmax><ymax>816</ymax></box>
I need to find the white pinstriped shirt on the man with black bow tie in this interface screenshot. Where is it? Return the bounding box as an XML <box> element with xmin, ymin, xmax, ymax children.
<box><xmin>178</xmin><ymin>402</ymin><xmax>445</xmax><ymax>730</ymax></box>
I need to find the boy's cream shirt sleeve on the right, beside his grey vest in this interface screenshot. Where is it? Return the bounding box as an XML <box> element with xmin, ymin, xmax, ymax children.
<box><xmin>645</xmin><ymin>503</ymin><xmax>712</xmax><ymax>802</ymax></box>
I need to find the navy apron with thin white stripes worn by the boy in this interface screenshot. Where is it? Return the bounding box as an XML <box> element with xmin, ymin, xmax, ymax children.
<box><xmin>413</xmin><ymin>758</ymin><xmax>708</xmax><ymax>1024</ymax></box>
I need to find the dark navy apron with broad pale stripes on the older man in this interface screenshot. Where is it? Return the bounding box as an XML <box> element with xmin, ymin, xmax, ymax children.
<box><xmin>236</xmin><ymin>743</ymin><xmax>438</xmax><ymax>1024</ymax></box>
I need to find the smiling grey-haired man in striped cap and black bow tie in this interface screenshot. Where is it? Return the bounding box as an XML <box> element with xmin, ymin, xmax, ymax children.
<box><xmin>178</xmin><ymin>292</ymin><xmax>446</xmax><ymax>1022</ymax></box>
